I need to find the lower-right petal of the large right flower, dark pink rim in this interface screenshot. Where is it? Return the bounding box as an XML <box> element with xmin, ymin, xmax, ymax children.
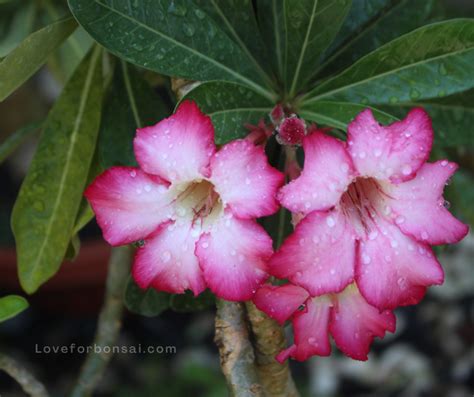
<box><xmin>356</xmin><ymin>213</ymin><xmax>444</xmax><ymax>310</ymax></box>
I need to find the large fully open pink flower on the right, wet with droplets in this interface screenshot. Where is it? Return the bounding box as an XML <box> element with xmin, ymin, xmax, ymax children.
<box><xmin>270</xmin><ymin>108</ymin><xmax>468</xmax><ymax>310</ymax></box>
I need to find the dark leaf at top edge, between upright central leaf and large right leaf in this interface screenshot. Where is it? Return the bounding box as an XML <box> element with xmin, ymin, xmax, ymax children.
<box><xmin>318</xmin><ymin>0</ymin><xmax>437</xmax><ymax>75</ymax></box>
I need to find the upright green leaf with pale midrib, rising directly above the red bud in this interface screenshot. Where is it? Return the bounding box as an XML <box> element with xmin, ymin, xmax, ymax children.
<box><xmin>258</xmin><ymin>0</ymin><xmax>351</xmax><ymax>96</ymax></box>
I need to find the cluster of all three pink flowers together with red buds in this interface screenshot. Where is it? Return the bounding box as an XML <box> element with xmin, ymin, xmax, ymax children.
<box><xmin>85</xmin><ymin>101</ymin><xmax>467</xmax><ymax>361</ymax></box>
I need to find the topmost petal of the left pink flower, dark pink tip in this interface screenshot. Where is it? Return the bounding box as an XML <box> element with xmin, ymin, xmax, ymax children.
<box><xmin>133</xmin><ymin>101</ymin><xmax>215</xmax><ymax>182</ymax></box>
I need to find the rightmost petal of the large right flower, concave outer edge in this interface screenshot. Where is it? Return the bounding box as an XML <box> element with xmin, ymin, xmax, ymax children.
<box><xmin>385</xmin><ymin>160</ymin><xmax>469</xmax><ymax>244</ymax></box>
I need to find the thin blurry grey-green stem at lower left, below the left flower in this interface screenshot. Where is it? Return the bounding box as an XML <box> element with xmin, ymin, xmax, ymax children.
<box><xmin>71</xmin><ymin>246</ymin><xmax>133</xmax><ymax>397</ymax></box>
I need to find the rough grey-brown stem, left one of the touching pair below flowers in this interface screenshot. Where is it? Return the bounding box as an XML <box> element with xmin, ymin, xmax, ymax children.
<box><xmin>214</xmin><ymin>300</ymin><xmax>264</xmax><ymax>397</ymax></box>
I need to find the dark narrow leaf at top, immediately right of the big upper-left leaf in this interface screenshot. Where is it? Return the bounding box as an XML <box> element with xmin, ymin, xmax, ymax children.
<box><xmin>195</xmin><ymin>0</ymin><xmax>271</xmax><ymax>85</ymax></box>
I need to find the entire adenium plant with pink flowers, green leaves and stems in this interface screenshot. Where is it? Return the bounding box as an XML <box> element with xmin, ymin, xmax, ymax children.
<box><xmin>0</xmin><ymin>0</ymin><xmax>474</xmax><ymax>396</ymax></box>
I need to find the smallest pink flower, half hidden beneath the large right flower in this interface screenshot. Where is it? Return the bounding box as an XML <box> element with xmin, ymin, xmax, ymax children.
<box><xmin>254</xmin><ymin>284</ymin><xmax>395</xmax><ymax>362</ymax></box>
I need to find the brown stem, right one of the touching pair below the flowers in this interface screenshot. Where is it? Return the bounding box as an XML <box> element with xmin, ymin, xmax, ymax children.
<box><xmin>246</xmin><ymin>302</ymin><xmax>299</xmax><ymax>397</ymax></box>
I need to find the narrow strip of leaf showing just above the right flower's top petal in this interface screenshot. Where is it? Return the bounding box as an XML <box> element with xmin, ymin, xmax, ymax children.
<box><xmin>298</xmin><ymin>101</ymin><xmax>397</xmax><ymax>131</ymax></box>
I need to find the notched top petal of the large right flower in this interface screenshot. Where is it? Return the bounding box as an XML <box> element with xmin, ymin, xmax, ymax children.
<box><xmin>347</xmin><ymin>108</ymin><xmax>433</xmax><ymax>183</ymax></box>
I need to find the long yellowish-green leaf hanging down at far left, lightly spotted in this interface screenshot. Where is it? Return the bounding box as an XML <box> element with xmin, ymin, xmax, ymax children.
<box><xmin>12</xmin><ymin>47</ymin><xmax>102</xmax><ymax>293</ymax></box>
